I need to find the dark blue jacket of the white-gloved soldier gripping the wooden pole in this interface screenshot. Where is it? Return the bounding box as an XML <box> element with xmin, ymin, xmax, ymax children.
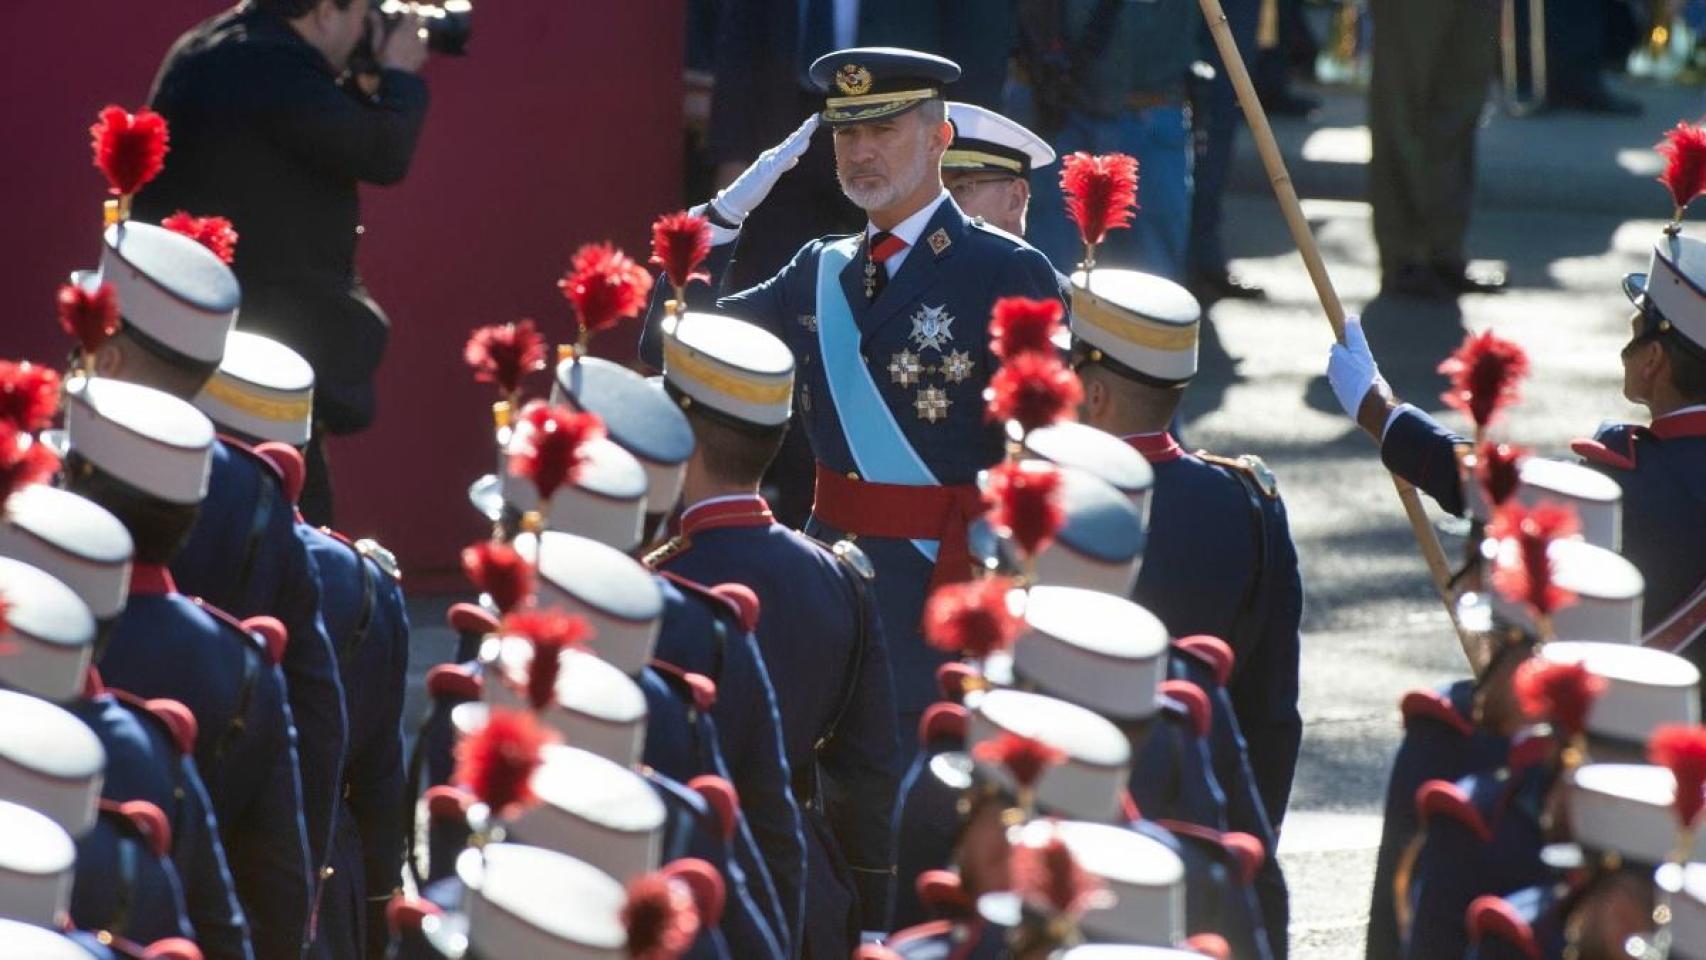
<box><xmin>1380</xmin><ymin>406</ymin><xmax>1706</xmax><ymax>641</ymax></box>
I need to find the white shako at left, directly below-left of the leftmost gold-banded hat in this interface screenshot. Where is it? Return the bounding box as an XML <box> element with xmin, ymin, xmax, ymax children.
<box><xmin>65</xmin><ymin>377</ymin><xmax>213</xmax><ymax>506</ymax></box>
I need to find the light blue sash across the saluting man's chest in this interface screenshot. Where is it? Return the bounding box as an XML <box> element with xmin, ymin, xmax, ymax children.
<box><xmin>817</xmin><ymin>237</ymin><xmax>940</xmax><ymax>563</ymax></box>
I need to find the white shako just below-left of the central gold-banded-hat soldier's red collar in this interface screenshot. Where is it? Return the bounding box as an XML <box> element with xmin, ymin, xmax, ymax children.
<box><xmin>515</xmin><ymin>530</ymin><xmax>664</xmax><ymax>677</ymax></box>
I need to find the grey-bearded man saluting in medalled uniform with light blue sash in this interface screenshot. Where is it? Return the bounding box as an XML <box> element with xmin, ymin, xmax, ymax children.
<box><xmin>640</xmin><ymin>48</ymin><xmax>1059</xmax><ymax>730</ymax></box>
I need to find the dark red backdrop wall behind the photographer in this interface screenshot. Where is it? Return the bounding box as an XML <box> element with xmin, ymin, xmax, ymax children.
<box><xmin>0</xmin><ymin>0</ymin><xmax>684</xmax><ymax>588</ymax></box>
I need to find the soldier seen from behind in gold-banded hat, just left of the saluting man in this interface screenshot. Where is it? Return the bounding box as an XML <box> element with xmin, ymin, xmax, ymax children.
<box><xmin>647</xmin><ymin>314</ymin><xmax>899</xmax><ymax>957</ymax></box>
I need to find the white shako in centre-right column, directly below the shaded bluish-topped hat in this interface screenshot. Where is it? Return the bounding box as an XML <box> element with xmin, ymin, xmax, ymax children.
<box><xmin>1012</xmin><ymin>587</ymin><xmax>1172</xmax><ymax>720</ymax></box>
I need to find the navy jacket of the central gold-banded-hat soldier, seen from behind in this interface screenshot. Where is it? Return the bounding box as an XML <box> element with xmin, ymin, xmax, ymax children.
<box><xmin>655</xmin><ymin>501</ymin><xmax>899</xmax><ymax>957</ymax></box>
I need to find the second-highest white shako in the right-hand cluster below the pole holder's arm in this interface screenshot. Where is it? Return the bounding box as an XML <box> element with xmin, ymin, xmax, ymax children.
<box><xmin>1483</xmin><ymin>539</ymin><xmax>1646</xmax><ymax>643</ymax></box>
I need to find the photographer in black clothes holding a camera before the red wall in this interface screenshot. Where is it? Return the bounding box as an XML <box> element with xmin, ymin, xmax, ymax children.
<box><xmin>135</xmin><ymin>0</ymin><xmax>428</xmax><ymax>523</ymax></box>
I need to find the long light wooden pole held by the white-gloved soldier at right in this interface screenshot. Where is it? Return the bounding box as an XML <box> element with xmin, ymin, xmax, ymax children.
<box><xmin>1201</xmin><ymin>0</ymin><xmax>1479</xmax><ymax>670</ymax></box>
